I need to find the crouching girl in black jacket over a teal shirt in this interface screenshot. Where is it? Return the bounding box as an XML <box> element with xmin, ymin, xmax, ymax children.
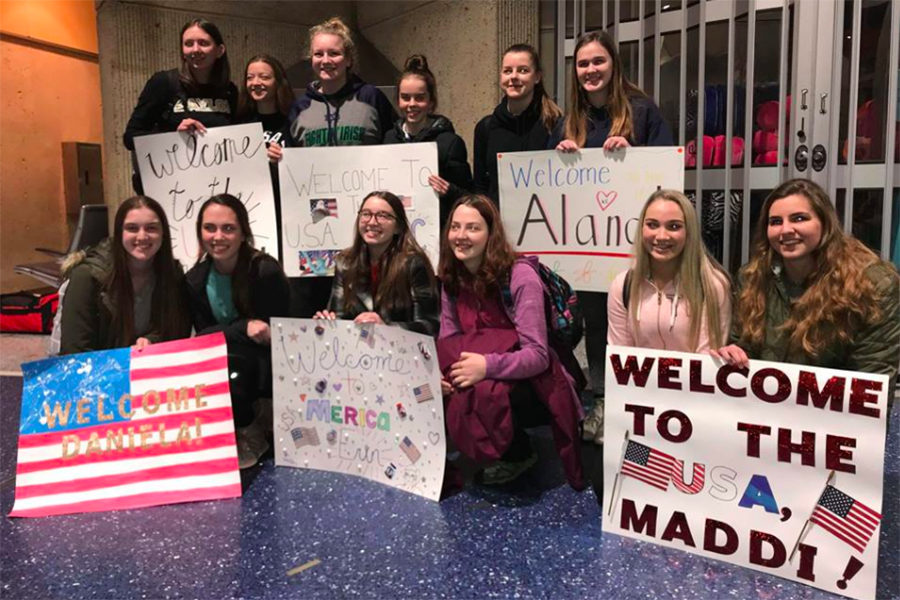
<box><xmin>185</xmin><ymin>194</ymin><xmax>290</xmax><ymax>469</ymax></box>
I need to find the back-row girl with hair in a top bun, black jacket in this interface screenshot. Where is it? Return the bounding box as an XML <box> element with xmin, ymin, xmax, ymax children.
<box><xmin>384</xmin><ymin>54</ymin><xmax>472</xmax><ymax>230</ymax></box>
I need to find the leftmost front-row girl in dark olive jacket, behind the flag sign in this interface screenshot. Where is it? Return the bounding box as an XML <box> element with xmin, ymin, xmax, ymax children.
<box><xmin>51</xmin><ymin>196</ymin><xmax>191</xmax><ymax>354</ymax></box>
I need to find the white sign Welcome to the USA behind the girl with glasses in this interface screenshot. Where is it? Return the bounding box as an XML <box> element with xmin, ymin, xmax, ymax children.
<box><xmin>279</xmin><ymin>142</ymin><xmax>440</xmax><ymax>277</ymax></box>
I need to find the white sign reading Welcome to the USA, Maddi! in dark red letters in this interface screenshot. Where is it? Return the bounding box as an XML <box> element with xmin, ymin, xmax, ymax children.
<box><xmin>603</xmin><ymin>346</ymin><xmax>888</xmax><ymax>598</ymax></box>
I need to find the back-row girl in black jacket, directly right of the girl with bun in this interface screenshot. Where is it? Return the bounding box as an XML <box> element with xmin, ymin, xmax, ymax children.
<box><xmin>472</xmin><ymin>44</ymin><xmax>562</xmax><ymax>205</ymax></box>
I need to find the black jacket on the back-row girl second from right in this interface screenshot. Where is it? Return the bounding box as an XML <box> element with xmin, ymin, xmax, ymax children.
<box><xmin>472</xmin><ymin>95</ymin><xmax>550</xmax><ymax>203</ymax></box>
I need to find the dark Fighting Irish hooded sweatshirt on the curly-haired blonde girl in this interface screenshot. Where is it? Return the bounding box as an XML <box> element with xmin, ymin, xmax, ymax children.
<box><xmin>288</xmin><ymin>75</ymin><xmax>397</xmax><ymax>147</ymax></box>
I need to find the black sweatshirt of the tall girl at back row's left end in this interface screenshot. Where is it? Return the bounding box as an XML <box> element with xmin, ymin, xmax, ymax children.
<box><xmin>122</xmin><ymin>69</ymin><xmax>237</xmax><ymax>150</ymax></box>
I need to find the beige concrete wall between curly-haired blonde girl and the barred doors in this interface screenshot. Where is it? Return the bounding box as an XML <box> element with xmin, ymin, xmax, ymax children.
<box><xmin>357</xmin><ymin>0</ymin><xmax>500</xmax><ymax>163</ymax></box>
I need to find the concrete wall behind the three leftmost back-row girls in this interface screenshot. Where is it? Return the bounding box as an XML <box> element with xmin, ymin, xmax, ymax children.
<box><xmin>97</xmin><ymin>0</ymin><xmax>355</xmax><ymax>209</ymax></box>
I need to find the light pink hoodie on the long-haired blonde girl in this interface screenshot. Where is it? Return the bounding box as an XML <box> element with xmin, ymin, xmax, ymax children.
<box><xmin>607</xmin><ymin>271</ymin><xmax>731</xmax><ymax>352</ymax></box>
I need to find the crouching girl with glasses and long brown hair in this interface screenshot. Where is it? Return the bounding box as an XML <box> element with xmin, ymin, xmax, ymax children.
<box><xmin>315</xmin><ymin>191</ymin><xmax>438</xmax><ymax>335</ymax></box>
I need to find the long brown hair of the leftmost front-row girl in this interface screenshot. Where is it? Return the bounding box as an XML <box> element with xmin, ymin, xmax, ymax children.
<box><xmin>105</xmin><ymin>196</ymin><xmax>190</xmax><ymax>346</ymax></box>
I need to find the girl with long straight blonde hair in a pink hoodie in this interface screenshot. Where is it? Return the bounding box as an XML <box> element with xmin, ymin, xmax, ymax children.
<box><xmin>607</xmin><ymin>190</ymin><xmax>731</xmax><ymax>352</ymax></box>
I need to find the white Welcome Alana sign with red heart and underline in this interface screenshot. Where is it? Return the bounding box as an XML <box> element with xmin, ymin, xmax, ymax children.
<box><xmin>497</xmin><ymin>147</ymin><xmax>684</xmax><ymax>292</ymax></box>
